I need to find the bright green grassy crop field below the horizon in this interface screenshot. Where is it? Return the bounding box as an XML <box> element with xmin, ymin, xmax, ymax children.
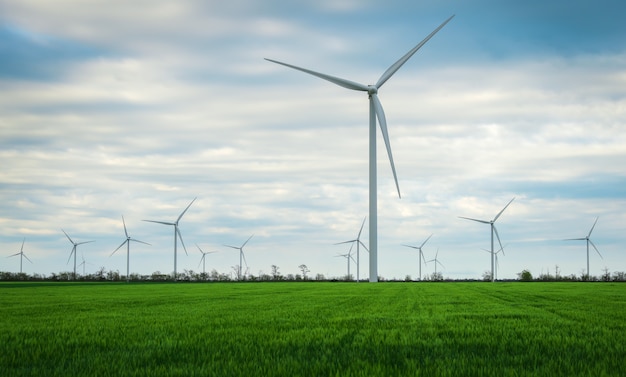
<box><xmin>0</xmin><ymin>282</ymin><xmax>626</xmax><ymax>376</ymax></box>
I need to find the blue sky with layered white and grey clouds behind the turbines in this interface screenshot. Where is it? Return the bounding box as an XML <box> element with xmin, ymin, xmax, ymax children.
<box><xmin>0</xmin><ymin>0</ymin><xmax>626</xmax><ymax>279</ymax></box>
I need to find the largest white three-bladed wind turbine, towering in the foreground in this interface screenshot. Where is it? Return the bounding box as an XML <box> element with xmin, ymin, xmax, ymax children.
<box><xmin>265</xmin><ymin>15</ymin><xmax>454</xmax><ymax>282</ymax></box>
